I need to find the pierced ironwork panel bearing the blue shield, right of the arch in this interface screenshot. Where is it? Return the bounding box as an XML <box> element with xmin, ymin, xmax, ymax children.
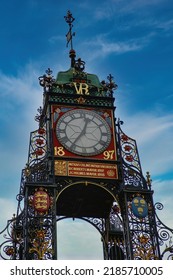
<box><xmin>124</xmin><ymin>192</ymin><xmax>161</xmax><ymax>260</ymax></box>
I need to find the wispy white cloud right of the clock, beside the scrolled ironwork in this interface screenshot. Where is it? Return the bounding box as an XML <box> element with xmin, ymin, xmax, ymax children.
<box><xmin>120</xmin><ymin>110</ymin><xmax>173</xmax><ymax>177</ymax></box>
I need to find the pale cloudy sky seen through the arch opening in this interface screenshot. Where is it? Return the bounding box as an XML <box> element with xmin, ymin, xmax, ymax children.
<box><xmin>57</xmin><ymin>219</ymin><xmax>103</xmax><ymax>260</ymax></box>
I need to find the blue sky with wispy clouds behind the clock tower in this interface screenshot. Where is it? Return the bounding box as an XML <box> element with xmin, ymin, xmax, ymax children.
<box><xmin>0</xmin><ymin>0</ymin><xmax>173</xmax><ymax>258</ymax></box>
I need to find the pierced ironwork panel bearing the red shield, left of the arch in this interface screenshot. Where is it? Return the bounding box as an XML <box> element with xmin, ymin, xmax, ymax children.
<box><xmin>24</xmin><ymin>185</ymin><xmax>56</xmax><ymax>260</ymax></box>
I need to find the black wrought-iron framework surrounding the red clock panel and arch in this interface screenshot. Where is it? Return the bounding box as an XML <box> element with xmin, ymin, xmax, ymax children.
<box><xmin>0</xmin><ymin>64</ymin><xmax>173</xmax><ymax>260</ymax></box>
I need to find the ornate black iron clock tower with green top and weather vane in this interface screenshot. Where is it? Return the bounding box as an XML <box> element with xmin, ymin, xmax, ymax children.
<box><xmin>2</xmin><ymin>12</ymin><xmax>172</xmax><ymax>260</ymax></box>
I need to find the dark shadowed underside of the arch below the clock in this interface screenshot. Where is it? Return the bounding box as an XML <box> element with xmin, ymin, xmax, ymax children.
<box><xmin>56</xmin><ymin>181</ymin><xmax>120</xmax><ymax>219</ymax></box>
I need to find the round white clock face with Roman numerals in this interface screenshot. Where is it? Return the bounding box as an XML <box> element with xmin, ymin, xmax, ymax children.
<box><xmin>56</xmin><ymin>109</ymin><xmax>111</xmax><ymax>156</ymax></box>
